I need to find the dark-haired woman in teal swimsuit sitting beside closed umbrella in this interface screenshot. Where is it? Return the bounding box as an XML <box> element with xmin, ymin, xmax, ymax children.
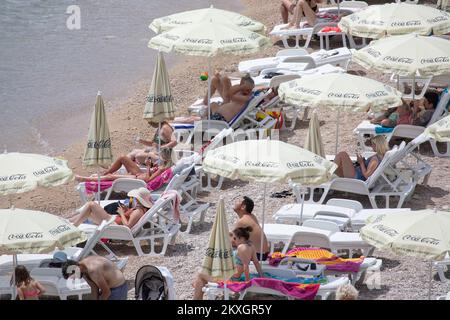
<box><xmin>193</xmin><ymin>227</ymin><xmax>263</xmax><ymax>300</ymax></box>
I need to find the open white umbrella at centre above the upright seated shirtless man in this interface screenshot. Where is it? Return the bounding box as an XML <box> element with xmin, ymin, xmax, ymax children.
<box><xmin>202</xmin><ymin>140</ymin><xmax>337</xmax><ymax>262</ymax></box>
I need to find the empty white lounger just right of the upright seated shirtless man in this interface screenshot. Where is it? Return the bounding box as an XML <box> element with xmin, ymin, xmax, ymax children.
<box><xmin>264</xmin><ymin>223</ymin><xmax>374</xmax><ymax>256</ymax></box>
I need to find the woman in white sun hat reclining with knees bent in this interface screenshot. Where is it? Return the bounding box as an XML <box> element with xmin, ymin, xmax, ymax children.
<box><xmin>69</xmin><ymin>187</ymin><xmax>152</xmax><ymax>228</ymax></box>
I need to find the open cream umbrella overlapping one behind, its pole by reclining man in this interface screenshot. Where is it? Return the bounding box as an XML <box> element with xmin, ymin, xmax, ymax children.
<box><xmin>148</xmin><ymin>19</ymin><xmax>271</xmax><ymax>118</ymax></box>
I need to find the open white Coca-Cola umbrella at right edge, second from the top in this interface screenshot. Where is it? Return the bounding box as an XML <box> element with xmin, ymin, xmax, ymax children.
<box><xmin>352</xmin><ymin>34</ymin><xmax>450</xmax><ymax>76</ymax></box>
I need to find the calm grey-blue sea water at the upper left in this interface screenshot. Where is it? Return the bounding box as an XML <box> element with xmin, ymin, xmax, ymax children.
<box><xmin>0</xmin><ymin>0</ymin><xmax>242</xmax><ymax>154</ymax></box>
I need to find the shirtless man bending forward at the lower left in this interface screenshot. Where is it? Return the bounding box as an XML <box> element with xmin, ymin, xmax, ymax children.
<box><xmin>62</xmin><ymin>256</ymin><xmax>128</xmax><ymax>300</ymax></box>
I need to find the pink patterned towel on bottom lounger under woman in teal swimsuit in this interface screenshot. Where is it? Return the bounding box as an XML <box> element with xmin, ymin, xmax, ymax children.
<box><xmin>219</xmin><ymin>278</ymin><xmax>320</xmax><ymax>300</ymax></box>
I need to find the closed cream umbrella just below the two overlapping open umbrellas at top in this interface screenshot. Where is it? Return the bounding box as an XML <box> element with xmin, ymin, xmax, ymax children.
<box><xmin>144</xmin><ymin>52</ymin><xmax>175</xmax><ymax>164</ymax></box>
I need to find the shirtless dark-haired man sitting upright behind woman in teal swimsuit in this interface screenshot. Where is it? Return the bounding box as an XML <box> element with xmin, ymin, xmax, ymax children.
<box><xmin>230</xmin><ymin>197</ymin><xmax>270</xmax><ymax>261</ymax></box>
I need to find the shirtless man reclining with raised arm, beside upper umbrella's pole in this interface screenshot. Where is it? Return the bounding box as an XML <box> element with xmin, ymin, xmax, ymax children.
<box><xmin>205</xmin><ymin>74</ymin><xmax>255</xmax><ymax>122</ymax></box>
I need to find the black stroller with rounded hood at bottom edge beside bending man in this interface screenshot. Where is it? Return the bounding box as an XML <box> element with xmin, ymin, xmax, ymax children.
<box><xmin>134</xmin><ymin>265</ymin><xmax>168</xmax><ymax>300</ymax></box>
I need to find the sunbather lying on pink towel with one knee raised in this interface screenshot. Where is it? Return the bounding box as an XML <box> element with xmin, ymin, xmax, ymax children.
<box><xmin>75</xmin><ymin>153</ymin><xmax>172</xmax><ymax>182</ymax></box>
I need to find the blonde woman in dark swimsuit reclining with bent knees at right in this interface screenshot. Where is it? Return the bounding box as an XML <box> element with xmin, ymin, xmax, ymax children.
<box><xmin>334</xmin><ymin>135</ymin><xmax>389</xmax><ymax>181</ymax></box>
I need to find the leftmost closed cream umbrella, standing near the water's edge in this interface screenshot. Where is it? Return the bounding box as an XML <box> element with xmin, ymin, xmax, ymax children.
<box><xmin>83</xmin><ymin>91</ymin><xmax>113</xmax><ymax>201</ymax></box>
